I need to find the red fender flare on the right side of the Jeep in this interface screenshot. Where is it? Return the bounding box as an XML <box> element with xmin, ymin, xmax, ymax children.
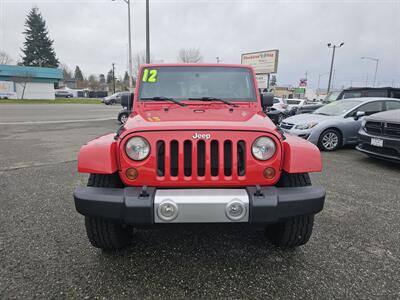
<box><xmin>282</xmin><ymin>135</ymin><xmax>322</xmax><ymax>173</ymax></box>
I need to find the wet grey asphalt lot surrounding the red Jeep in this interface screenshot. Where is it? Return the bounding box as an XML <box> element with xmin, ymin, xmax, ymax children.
<box><xmin>0</xmin><ymin>105</ymin><xmax>400</xmax><ymax>299</ymax></box>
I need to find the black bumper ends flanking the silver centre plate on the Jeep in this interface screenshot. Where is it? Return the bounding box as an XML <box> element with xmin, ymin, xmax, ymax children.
<box><xmin>74</xmin><ymin>186</ymin><xmax>325</xmax><ymax>225</ymax></box>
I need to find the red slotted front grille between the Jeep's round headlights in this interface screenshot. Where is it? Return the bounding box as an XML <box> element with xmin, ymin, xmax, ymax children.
<box><xmin>156</xmin><ymin>140</ymin><xmax>246</xmax><ymax>180</ymax></box>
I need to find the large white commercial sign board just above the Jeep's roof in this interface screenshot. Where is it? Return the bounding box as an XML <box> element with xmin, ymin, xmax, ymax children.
<box><xmin>241</xmin><ymin>50</ymin><xmax>279</xmax><ymax>74</ymax></box>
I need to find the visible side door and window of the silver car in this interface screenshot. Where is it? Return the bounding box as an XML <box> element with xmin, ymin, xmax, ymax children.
<box><xmin>344</xmin><ymin>101</ymin><xmax>385</xmax><ymax>143</ymax></box>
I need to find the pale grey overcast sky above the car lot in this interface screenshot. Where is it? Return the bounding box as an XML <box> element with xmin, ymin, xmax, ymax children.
<box><xmin>0</xmin><ymin>0</ymin><xmax>400</xmax><ymax>87</ymax></box>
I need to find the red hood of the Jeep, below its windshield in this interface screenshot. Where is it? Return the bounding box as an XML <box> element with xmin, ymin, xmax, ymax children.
<box><xmin>125</xmin><ymin>105</ymin><xmax>276</xmax><ymax>131</ymax></box>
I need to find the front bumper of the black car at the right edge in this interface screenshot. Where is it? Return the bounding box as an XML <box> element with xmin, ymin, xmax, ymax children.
<box><xmin>356</xmin><ymin>129</ymin><xmax>400</xmax><ymax>162</ymax></box>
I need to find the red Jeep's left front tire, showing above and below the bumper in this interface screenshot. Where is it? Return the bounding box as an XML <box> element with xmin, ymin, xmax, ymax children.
<box><xmin>85</xmin><ymin>173</ymin><xmax>132</xmax><ymax>250</ymax></box>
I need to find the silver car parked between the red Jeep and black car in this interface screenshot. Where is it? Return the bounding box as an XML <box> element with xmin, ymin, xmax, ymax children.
<box><xmin>280</xmin><ymin>98</ymin><xmax>400</xmax><ymax>151</ymax></box>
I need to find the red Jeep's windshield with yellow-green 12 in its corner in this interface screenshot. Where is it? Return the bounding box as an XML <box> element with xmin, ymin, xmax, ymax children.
<box><xmin>139</xmin><ymin>67</ymin><xmax>256</xmax><ymax>102</ymax></box>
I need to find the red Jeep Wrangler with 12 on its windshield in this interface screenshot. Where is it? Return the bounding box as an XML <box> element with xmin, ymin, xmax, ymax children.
<box><xmin>74</xmin><ymin>64</ymin><xmax>325</xmax><ymax>249</ymax></box>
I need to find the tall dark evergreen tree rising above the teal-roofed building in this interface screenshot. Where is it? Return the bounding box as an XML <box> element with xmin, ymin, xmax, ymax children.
<box><xmin>21</xmin><ymin>7</ymin><xmax>59</xmax><ymax>67</ymax></box>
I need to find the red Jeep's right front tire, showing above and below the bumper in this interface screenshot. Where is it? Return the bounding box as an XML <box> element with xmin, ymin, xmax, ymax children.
<box><xmin>266</xmin><ymin>173</ymin><xmax>314</xmax><ymax>248</ymax></box>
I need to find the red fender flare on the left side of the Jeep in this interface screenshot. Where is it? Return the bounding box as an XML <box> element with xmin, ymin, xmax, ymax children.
<box><xmin>78</xmin><ymin>133</ymin><xmax>118</xmax><ymax>174</ymax></box>
